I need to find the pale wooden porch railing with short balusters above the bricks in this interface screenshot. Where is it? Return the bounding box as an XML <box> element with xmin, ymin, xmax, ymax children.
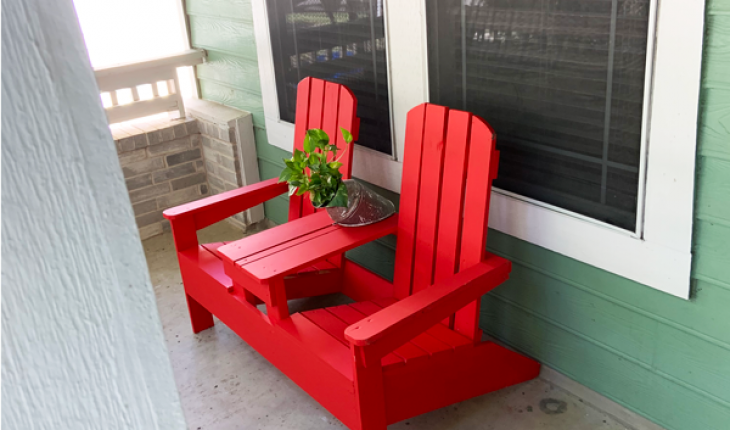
<box><xmin>94</xmin><ymin>49</ymin><xmax>207</xmax><ymax>124</ymax></box>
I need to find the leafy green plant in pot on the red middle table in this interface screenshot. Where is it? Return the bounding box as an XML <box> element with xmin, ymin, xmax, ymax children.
<box><xmin>279</xmin><ymin>128</ymin><xmax>395</xmax><ymax>226</ymax></box>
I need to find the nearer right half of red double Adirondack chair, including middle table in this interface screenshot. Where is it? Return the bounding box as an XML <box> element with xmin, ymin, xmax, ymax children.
<box><xmin>167</xmin><ymin>100</ymin><xmax>539</xmax><ymax>430</ymax></box>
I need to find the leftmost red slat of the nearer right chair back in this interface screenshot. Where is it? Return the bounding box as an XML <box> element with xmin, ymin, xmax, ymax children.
<box><xmin>393</xmin><ymin>104</ymin><xmax>427</xmax><ymax>298</ymax></box>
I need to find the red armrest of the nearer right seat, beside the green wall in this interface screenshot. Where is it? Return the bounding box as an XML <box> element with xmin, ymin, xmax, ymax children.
<box><xmin>345</xmin><ymin>253</ymin><xmax>512</xmax><ymax>355</ymax></box>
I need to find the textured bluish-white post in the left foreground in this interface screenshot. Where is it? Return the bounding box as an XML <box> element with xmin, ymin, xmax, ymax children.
<box><xmin>2</xmin><ymin>0</ymin><xmax>185</xmax><ymax>430</ymax></box>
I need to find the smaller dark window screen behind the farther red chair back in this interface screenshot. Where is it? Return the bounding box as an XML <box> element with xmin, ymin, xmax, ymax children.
<box><xmin>266</xmin><ymin>0</ymin><xmax>392</xmax><ymax>155</ymax></box>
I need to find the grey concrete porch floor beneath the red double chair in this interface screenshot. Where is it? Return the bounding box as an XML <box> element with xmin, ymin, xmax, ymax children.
<box><xmin>143</xmin><ymin>223</ymin><xmax>629</xmax><ymax>430</ymax></box>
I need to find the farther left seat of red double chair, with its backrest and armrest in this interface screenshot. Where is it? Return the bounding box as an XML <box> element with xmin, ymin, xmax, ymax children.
<box><xmin>164</xmin><ymin>78</ymin><xmax>360</xmax><ymax>333</ymax></box>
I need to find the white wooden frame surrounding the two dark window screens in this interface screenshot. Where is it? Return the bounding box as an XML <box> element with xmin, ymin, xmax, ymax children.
<box><xmin>252</xmin><ymin>0</ymin><xmax>705</xmax><ymax>299</ymax></box>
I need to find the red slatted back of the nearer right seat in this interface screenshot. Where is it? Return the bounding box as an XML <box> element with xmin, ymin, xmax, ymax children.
<box><xmin>394</xmin><ymin>103</ymin><xmax>499</xmax><ymax>336</ymax></box>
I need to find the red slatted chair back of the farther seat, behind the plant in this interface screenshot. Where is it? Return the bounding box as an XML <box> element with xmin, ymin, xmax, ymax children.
<box><xmin>289</xmin><ymin>78</ymin><xmax>360</xmax><ymax>221</ymax></box>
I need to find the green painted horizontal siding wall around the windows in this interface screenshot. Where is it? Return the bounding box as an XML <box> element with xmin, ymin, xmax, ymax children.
<box><xmin>187</xmin><ymin>0</ymin><xmax>730</xmax><ymax>430</ymax></box>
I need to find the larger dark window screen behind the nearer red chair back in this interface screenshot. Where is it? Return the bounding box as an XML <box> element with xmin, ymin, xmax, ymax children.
<box><xmin>427</xmin><ymin>0</ymin><xmax>650</xmax><ymax>230</ymax></box>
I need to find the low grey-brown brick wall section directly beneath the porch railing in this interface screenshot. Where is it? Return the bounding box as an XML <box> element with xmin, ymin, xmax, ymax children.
<box><xmin>111</xmin><ymin>118</ymin><xmax>208</xmax><ymax>240</ymax></box>
